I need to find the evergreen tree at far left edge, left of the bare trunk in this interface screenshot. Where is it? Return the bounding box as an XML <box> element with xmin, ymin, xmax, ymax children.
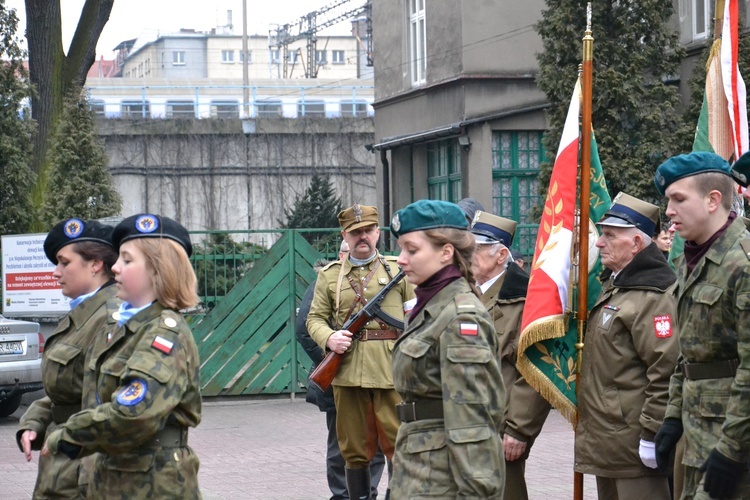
<box><xmin>0</xmin><ymin>2</ymin><xmax>35</xmax><ymax>234</ymax></box>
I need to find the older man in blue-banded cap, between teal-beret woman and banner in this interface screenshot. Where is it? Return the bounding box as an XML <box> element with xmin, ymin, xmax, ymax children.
<box><xmin>471</xmin><ymin>211</ymin><xmax>550</xmax><ymax>500</ymax></box>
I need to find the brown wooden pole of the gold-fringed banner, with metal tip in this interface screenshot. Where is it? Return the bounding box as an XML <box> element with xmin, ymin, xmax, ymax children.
<box><xmin>573</xmin><ymin>2</ymin><xmax>594</xmax><ymax>500</ymax></box>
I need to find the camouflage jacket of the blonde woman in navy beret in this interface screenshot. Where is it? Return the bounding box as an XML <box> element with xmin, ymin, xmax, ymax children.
<box><xmin>48</xmin><ymin>302</ymin><xmax>201</xmax><ymax>498</ymax></box>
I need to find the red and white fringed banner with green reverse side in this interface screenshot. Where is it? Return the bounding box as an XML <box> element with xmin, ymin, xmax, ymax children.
<box><xmin>517</xmin><ymin>82</ymin><xmax>611</xmax><ymax>424</ymax></box>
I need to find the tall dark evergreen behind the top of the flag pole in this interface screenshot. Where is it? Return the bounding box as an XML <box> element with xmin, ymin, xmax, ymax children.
<box><xmin>537</xmin><ymin>0</ymin><xmax>685</xmax><ymax>204</ymax></box>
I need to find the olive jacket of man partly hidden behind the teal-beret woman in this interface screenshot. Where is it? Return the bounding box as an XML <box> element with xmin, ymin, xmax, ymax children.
<box><xmin>481</xmin><ymin>263</ymin><xmax>550</xmax><ymax>459</ymax></box>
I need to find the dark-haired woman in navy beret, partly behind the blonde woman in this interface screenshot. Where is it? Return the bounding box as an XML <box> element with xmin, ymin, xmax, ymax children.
<box><xmin>16</xmin><ymin>219</ymin><xmax>117</xmax><ymax>499</ymax></box>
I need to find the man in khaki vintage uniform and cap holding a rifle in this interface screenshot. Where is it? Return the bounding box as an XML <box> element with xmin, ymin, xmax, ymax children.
<box><xmin>307</xmin><ymin>205</ymin><xmax>415</xmax><ymax>499</ymax></box>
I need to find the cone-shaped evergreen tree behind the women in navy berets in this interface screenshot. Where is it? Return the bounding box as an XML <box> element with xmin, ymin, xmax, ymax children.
<box><xmin>41</xmin><ymin>90</ymin><xmax>122</xmax><ymax>226</ymax></box>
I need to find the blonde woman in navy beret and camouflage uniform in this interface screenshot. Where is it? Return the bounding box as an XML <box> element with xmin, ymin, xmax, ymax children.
<box><xmin>42</xmin><ymin>214</ymin><xmax>201</xmax><ymax>499</ymax></box>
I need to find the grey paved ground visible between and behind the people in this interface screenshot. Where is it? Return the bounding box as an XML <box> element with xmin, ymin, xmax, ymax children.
<box><xmin>0</xmin><ymin>391</ymin><xmax>596</xmax><ymax>500</ymax></box>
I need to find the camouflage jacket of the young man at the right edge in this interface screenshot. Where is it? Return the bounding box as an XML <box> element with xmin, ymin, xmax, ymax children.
<box><xmin>666</xmin><ymin>217</ymin><xmax>750</xmax><ymax>467</ymax></box>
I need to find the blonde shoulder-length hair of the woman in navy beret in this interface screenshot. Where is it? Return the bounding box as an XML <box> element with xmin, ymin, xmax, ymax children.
<box><xmin>130</xmin><ymin>238</ymin><xmax>200</xmax><ymax>310</ymax></box>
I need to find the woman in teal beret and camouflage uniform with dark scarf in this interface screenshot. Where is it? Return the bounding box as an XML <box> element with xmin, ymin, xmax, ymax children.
<box><xmin>391</xmin><ymin>200</ymin><xmax>505</xmax><ymax>499</ymax></box>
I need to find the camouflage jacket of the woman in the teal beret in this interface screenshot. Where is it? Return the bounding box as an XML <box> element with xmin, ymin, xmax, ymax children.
<box><xmin>390</xmin><ymin>278</ymin><xmax>505</xmax><ymax>498</ymax></box>
